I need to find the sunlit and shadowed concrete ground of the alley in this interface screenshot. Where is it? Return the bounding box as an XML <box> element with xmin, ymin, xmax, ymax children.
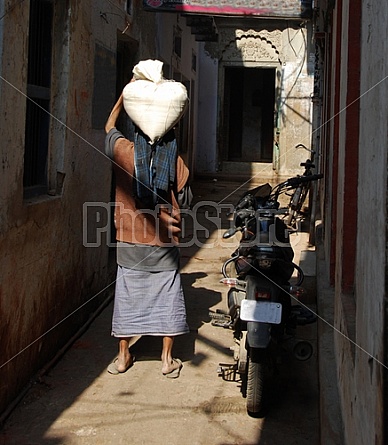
<box><xmin>0</xmin><ymin>180</ymin><xmax>324</xmax><ymax>445</ymax></box>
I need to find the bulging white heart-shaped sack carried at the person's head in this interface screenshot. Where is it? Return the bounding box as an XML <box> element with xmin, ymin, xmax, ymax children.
<box><xmin>123</xmin><ymin>60</ymin><xmax>188</xmax><ymax>144</ymax></box>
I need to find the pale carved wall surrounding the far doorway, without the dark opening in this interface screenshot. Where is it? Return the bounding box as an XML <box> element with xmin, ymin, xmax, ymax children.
<box><xmin>197</xmin><ymin>21</ymin><xmax>313</xmax><ymax>175</ymax></box>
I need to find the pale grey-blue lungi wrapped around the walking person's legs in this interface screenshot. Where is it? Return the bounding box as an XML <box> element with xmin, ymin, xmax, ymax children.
<box><xmin>112</xmin><ymin>266</ymin><xmax>189</xmax><ymax>337</ymax></box>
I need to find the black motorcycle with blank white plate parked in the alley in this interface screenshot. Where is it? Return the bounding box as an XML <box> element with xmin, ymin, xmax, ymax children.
<box><xmin>209</xmin><ymin>175</ymin><xmax>322</xmax><ymax>417</ymax></box>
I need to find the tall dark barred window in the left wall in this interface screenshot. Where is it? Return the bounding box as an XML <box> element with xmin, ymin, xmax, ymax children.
<box><xmin>23</xmin><ymin>0</ymin><xmax>53</xmax><ymax>197</ymax></box>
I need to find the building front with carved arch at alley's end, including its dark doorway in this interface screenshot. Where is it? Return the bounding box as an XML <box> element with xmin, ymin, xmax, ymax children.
<box><xmin>196</xmin><ymin>18</ymin><xmax>314</xmax><ymax>178</ymax></box>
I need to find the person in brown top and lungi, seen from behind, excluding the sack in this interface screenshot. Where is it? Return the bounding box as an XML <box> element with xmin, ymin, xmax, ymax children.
<box><xmin>105</xmin><ymin>62</ymin><xmax>189</xmax><ymax>378</ymax></box>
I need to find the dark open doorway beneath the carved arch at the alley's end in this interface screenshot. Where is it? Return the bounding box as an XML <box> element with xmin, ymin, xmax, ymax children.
<box><xmin>222</xmin><ymin>66</ymin><xmax>276</xmax><ymax>163</ymax></box>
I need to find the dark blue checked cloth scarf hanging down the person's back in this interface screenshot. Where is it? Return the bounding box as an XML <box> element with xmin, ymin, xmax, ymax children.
<box><xmin>134</xmin><ymin>130</ymin><xmax>178</xmax><ymax>208</ymax></box>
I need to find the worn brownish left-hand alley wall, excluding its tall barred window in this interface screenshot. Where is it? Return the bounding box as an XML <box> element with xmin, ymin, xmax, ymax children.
<box><xmin>0</xmin><ymin>0</ymin><xmax>196</xmax><ymax>413</ymax></box>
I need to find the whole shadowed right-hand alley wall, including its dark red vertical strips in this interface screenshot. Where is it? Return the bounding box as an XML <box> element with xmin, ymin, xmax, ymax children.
<box><xmin>316</xmin><ymin>0</ymin><xmax>388</xmax><ymax>444</ymax></box>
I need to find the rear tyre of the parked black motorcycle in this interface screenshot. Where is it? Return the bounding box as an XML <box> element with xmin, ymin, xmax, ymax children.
<box><xmin>246</xmin><ymin>348</ymin><xmax>269</xmax><ymax>417</ymax></box>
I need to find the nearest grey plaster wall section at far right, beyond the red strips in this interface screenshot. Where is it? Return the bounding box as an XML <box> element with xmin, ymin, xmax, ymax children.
<box><xmin>348</xmin><ymin>2</ymin><xmax>388</xmax><ymax>444</ymax></box>
